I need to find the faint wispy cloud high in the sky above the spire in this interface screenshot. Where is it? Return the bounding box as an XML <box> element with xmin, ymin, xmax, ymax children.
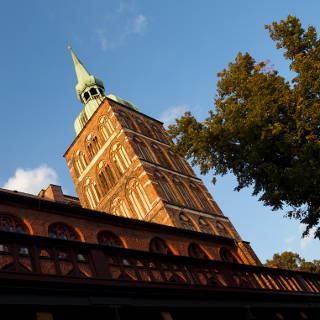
<box><xmin>95</xmin><ymin>9</ymin><xmax>148</xmax><ymax>51</ymax></box>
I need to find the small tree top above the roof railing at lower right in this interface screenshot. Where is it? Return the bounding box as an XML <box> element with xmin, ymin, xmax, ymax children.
<box><xmin>264</xmin><ymin>251</ymin><xmax>320</xmax><ymax>273</ymax></box>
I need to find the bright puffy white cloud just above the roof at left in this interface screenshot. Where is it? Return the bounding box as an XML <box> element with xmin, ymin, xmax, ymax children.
<box><xmin>3</xmin><ymin>164</ymin><xmax>58</xmax><ymax>194</ymax></box>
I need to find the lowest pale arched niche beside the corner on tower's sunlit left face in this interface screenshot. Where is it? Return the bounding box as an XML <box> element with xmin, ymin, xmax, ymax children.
<box><xmin>127</xmin><ymin>179</ymin><xmax>151</xmax><ymax>219</ymax></box>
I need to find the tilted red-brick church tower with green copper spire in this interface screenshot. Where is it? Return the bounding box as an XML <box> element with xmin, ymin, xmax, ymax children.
<box><xmin>64</xmin><ymin>48</ymin><xmax>259</xmax><ymax>264</ymax></box>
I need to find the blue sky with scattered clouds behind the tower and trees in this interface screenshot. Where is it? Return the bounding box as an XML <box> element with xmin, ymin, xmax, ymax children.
<box><xmin>0</xmin><ymin>0</ymin><xmax>320</xmax><ymax>261</ymax></box>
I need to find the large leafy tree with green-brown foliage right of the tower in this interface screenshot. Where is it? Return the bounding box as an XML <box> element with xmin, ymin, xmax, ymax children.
<box><xmin>168</xmin><ymin>16</ymin><xmax>320</xmax><ymax>238</ymax></box>
